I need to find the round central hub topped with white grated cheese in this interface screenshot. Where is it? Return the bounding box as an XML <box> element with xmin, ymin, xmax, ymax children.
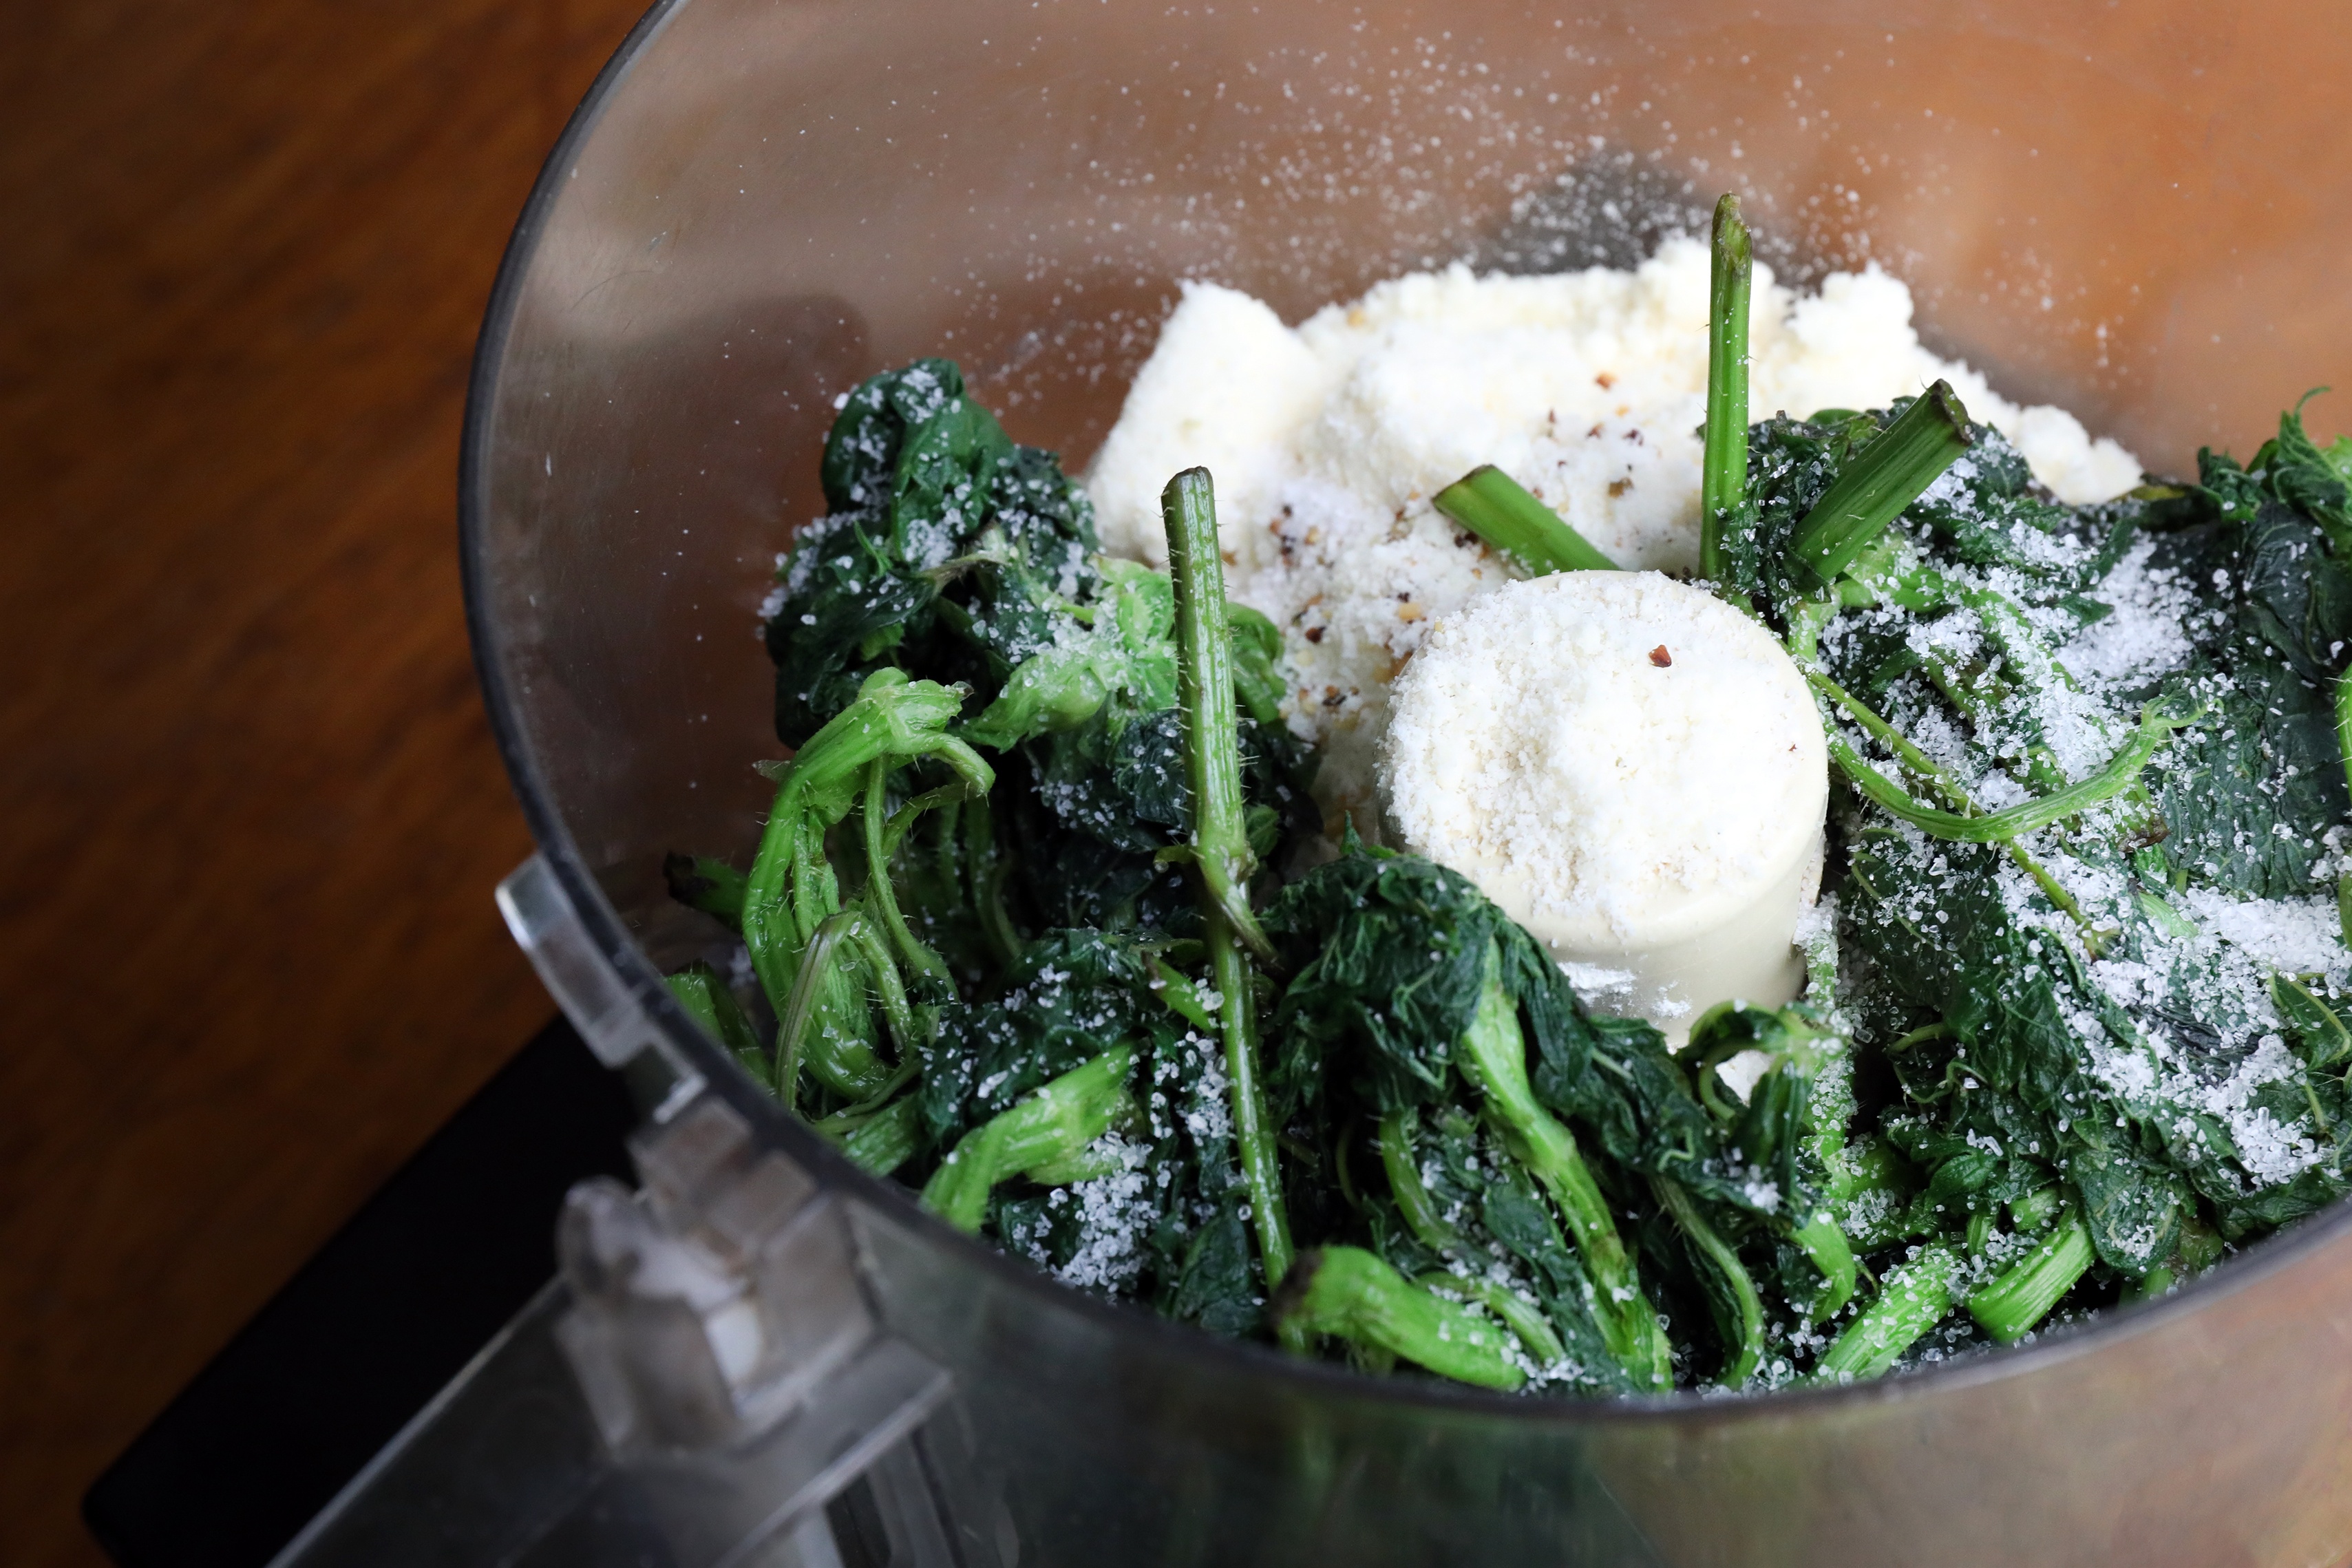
<box><xmin>1381</xmin><ymin>571</ymin><xmax>1830</xmax><ymax>1035</ymax></box>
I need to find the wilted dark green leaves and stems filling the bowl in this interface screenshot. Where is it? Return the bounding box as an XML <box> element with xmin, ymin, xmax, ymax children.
<box><xmin>668</xmin><ymin>200</ymin><xmax>2352</xmax><ymax>1397</ymax></box>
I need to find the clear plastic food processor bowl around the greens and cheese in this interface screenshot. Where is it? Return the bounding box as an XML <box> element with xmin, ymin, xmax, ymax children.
<box><xmin>312</xmin><ymin>0</ymin><xmax>2352</xmax><ymax>1568</ymax></box>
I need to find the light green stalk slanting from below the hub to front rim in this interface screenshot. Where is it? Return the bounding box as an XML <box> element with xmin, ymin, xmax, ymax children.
<box><xmin>1454</xmin><ymin>952</ymin><xmax>1675</xmax><ymax>1392</ymax></box>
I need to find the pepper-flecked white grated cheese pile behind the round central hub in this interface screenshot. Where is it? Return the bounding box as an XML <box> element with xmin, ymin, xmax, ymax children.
<box><xmin>1087</xmin><ymin>240</ymin><xmax>2140</xmax><ymax>832</ymax></box>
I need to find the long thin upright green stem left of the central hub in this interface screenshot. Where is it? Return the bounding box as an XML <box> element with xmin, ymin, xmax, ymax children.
<box><xmin>1160</xmin><ymin>468</ymin><xmax>1291</xmax><ymax>1291</ymax></box>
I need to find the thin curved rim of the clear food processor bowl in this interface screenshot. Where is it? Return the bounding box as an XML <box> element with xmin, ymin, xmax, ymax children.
<box><xmin>456</xmin><ymin>0</ymin><xmax>2352</xmax><ymax>1429</ymax></box>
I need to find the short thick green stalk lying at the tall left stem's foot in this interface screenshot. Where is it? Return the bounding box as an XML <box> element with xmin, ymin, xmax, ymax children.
<box><xmin>1270</xmin><ymin>1246</ymin><xmax>1527</xmax><ymax>1392</ymax></box>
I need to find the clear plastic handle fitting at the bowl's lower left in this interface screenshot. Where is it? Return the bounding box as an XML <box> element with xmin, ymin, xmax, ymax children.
<box><xmin>277</xmin><ymin>1096</ymin><xmax>957</xmax><ymax>1568</ymax></box>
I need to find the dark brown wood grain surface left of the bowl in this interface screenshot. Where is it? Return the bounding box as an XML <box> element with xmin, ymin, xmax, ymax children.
<box><xmin>0</xmin><ymin>0</ymin><xmax>642</xmax><ymax>1566</ymax></box>
